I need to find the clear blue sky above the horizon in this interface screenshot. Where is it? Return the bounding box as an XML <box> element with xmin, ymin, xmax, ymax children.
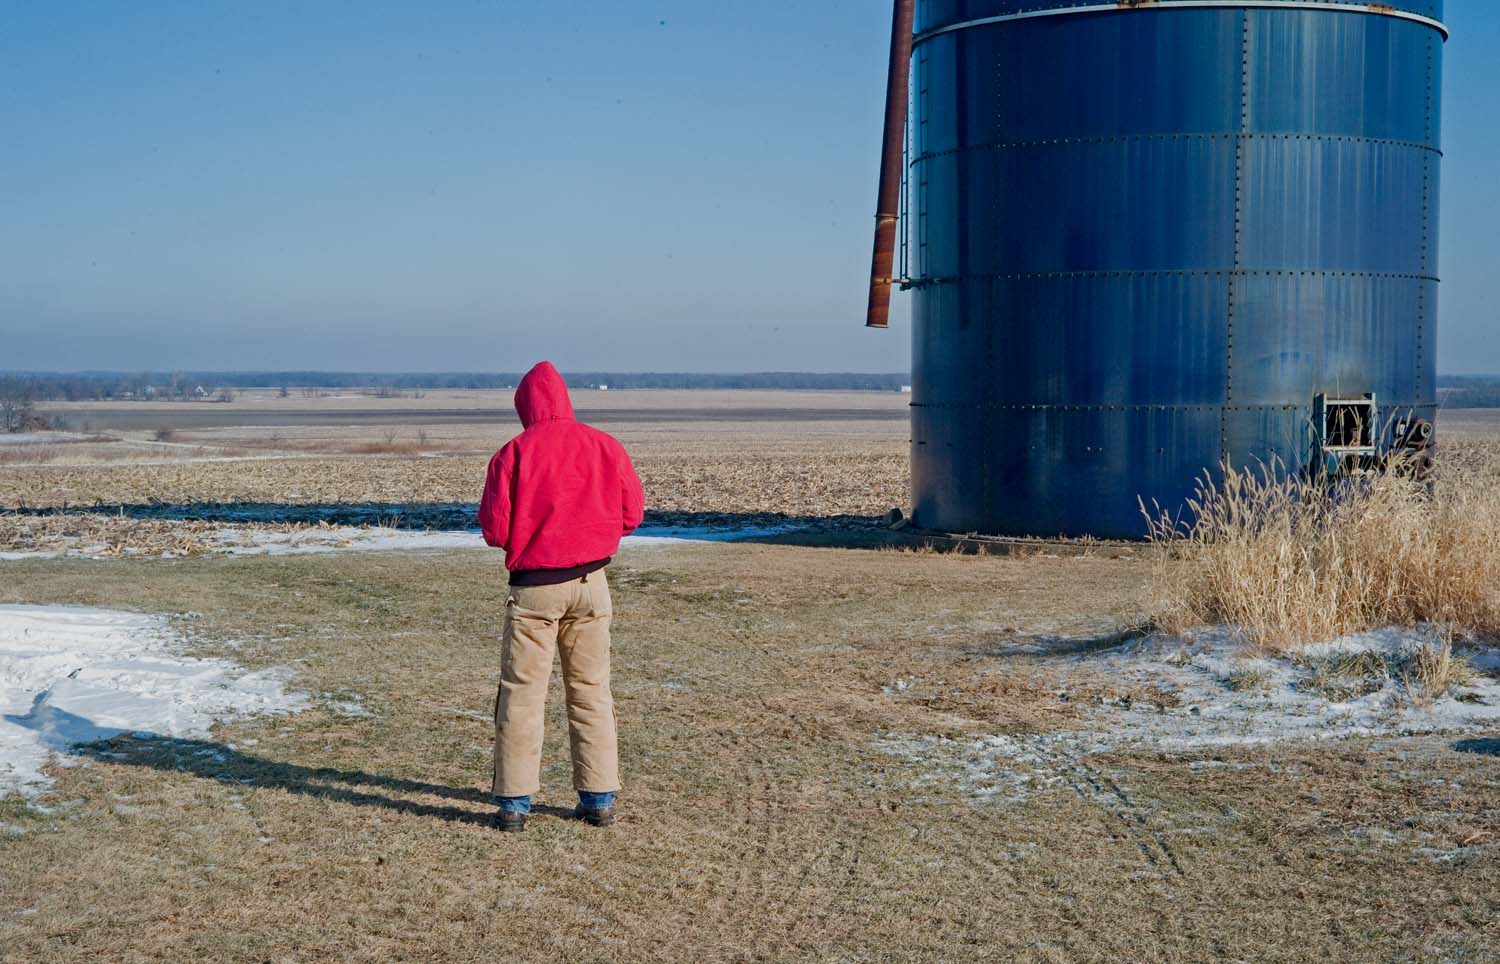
<box><xmin>0</xmin><ymin>0</ymin><xmax>1500</xmax><ymax>372</ymax></box>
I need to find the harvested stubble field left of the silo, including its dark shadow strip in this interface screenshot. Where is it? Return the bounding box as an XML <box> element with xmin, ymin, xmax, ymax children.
<box><xmin>0</xmin><ymin>391</ymin><xmax>909</xmax><ymax>555</ymax></box>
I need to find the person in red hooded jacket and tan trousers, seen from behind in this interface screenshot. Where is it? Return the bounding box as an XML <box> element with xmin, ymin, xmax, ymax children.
<box><xmin>479</xmin><ymin>361</ymin><xmax>645</xmax><ymax>832</ymax></box>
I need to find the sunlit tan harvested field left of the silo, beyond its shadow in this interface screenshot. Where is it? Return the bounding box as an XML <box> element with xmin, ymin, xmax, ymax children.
<box><xmin>0</xmin><ymin>391</ymin><xmax>909</xmax><ymax>516</ymax></box>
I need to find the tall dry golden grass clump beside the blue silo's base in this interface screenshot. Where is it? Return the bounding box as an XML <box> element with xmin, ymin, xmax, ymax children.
<box><xmin>1148</xmin><ymin>441</ymin><xmax>1500</xmax><ymax>649</ymax></box>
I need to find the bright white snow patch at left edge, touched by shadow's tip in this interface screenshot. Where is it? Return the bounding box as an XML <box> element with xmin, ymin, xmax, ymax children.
<box><xmin>0</xmin><ymin>606</ymin><xmax>309</xmax><ymax>796</ymax></box>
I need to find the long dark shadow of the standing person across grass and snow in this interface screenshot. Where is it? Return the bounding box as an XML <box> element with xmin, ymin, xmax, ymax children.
<box><xmin>53</xmin><ymin>709</ymin><xmax>573</xmax><ymax>826</ymax></box>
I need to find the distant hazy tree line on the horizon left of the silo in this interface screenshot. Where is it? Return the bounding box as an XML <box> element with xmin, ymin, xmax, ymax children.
<box><xmin>6</xmin><ymin>372</ymin><xmax>912</xmax><ymax>402</ymax></box>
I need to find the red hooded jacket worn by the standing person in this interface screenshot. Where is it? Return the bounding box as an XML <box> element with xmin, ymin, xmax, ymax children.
<box><xmin>479</xmin><ymin>361</ymin><xmax>645</xmax><ymax>571</ymax></box>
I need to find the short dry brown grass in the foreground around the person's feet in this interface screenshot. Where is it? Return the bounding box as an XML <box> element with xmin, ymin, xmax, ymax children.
<box><xmin>0</xmin><ymin>546</ymin><xmax>1500</xmax><ymax>961</ymax></box>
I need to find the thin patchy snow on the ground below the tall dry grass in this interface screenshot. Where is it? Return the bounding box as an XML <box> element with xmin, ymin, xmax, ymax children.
<box><xmin>878</xmin><ymin>630</ymin><xmax>1500</xmax><ymax>802</ymax></box>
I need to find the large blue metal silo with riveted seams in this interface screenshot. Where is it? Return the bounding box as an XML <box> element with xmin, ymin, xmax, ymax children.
<box><xmin>909</xmin><ymin>0</ymin><xmax>1443</xmax><ymax>538</ymax></box>
